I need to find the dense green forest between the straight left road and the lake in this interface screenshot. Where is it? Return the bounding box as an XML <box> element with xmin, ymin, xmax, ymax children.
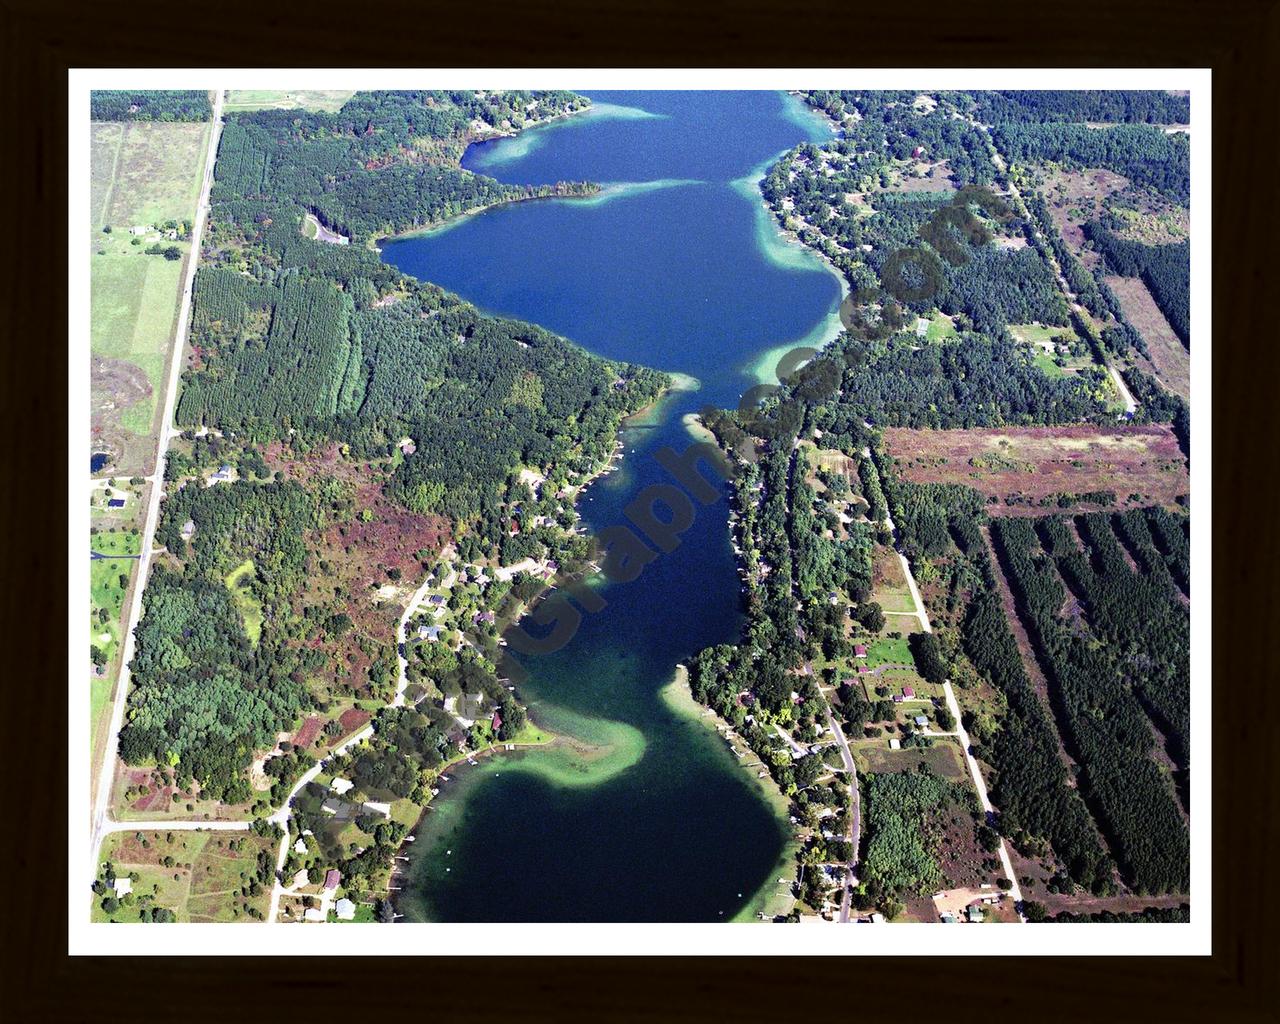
<box><xmin>120</xmin><ymin>92</ymin><xmax>668</xmax><ymax>808</ymax></box>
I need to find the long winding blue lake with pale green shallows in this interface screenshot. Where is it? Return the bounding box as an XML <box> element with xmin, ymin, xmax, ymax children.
<box><xmin>383</xmin><ymin>92</ymin><xmax>840</xmax><ymax>922</ymax></box>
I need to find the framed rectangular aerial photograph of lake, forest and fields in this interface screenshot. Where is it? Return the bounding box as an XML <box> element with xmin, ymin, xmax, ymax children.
<box><xmin>85</xmin><ymin>83</ymin><xmax>1192</xmax><ymax>943</ymax></box>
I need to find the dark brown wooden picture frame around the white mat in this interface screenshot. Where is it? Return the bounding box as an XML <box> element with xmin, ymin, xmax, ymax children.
<box><xmin>0</xmin><ymin>0</ymin><xmax>1280</xmax><ymax>1021</ymax></box>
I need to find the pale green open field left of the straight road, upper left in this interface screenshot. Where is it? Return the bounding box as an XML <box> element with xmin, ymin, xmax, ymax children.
<box><xmin>90</xmin><ymin>123</ymin><xmax>210</xmax><ymax>474</ymax></box>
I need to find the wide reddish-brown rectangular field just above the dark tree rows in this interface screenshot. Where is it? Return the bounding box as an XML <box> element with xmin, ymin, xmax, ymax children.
<box><xmin>884</xmin><ymin>425</ymin><xmax>1190</xmax><ymax>516</ymax></box>
